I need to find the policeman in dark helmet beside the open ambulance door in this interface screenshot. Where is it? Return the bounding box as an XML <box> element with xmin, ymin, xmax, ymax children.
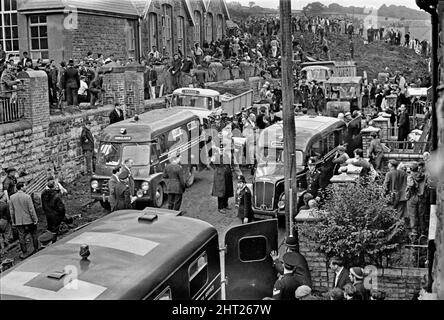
<box><xmin>270</xmin><ymin>236</ymin><xmax>312</xmax><ymax>287</ymax></box>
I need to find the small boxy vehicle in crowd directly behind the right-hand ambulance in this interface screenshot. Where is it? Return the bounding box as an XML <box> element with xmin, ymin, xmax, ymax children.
<box><xmin>325</xmin><ymin>77</ymin><xmax>363</xmax><ymax>114</ymax></box>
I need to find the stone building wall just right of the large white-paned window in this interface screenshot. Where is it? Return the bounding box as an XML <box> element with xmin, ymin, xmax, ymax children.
<box><xmin>65</xmin><ymin>13</ymin><xmax>134</xmax><ymax>59</ymax></box>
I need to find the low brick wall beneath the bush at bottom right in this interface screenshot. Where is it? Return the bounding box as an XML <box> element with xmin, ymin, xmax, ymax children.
<box><xmin>299</xmin><ymin>226</ymin><xmax>427</xmax><ymax>300</ymax></box>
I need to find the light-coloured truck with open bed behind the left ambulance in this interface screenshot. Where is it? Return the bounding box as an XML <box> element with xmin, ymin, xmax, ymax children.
<box><xmin>170</xmin><ymin>87</ymin><xmax>253</xmax><ymax>124</ymax></box>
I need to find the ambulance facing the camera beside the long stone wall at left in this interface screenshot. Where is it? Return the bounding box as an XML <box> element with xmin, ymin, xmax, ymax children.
<box><xmin>90</xmin><ymin>109</ymin><xmax>202</xmax><ymax>209</ymax></box>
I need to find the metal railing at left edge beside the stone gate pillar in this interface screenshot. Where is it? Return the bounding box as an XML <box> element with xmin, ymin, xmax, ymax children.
<box><xmin>0</xmin><ymin>90</ymin><xmax>25</xmax><ymax>124</ymax></box>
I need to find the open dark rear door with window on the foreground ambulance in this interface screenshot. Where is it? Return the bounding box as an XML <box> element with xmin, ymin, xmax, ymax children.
<box><xmin>225</xmin><ymin>219</ymin><xmax>278</xmax><ymax>300</ymax></box>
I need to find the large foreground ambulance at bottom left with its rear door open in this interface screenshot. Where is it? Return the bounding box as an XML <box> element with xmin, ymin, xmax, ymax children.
<box><xmin>0</xmin><ymin>208</ymin><xmax>277</xmax><ymax>300</ymax></box>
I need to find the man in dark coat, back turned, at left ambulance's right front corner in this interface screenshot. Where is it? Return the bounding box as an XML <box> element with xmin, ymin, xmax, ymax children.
<box><xmin>163</xmin><ymin>154</ymin><xmax>186</xmax><ymax>210</ymax></box>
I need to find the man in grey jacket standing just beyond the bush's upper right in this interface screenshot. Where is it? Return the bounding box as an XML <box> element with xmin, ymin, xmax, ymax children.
<box><xmin>384</xmin><ymin>159</ymin><xmax>407</xmax><ymax>218</ymax></box>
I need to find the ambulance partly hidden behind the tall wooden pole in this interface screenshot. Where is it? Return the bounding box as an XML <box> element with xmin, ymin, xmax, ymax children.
<box><xmin>252</xmin><ymin>115</ymin><xmax>347</xmax><ymax>217</ymax></box>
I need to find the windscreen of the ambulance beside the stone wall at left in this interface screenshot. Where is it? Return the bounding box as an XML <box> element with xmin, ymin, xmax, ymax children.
<box><xmin>97</xmin><ymin>142</ymin><xmax>150</xmax><ymax>166</ymax></box>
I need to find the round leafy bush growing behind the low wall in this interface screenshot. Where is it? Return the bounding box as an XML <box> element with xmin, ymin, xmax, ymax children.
<box><xmin>300</xmin><ymin>182</ymin><xmax>406</xmax><ymax>267</ymax></box>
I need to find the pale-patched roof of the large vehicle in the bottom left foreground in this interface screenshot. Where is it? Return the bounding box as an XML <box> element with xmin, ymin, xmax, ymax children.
<box><xmin>0</xmin><ymin>208</ymin><xmax>217</xmax><ymax>300</ymax></box>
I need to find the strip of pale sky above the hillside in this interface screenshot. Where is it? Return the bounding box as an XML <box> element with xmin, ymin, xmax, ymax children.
<box><xmin>236</xmin><ymin>0</ymin><xmax>419</xmax><ymax>10</ymax></box>
